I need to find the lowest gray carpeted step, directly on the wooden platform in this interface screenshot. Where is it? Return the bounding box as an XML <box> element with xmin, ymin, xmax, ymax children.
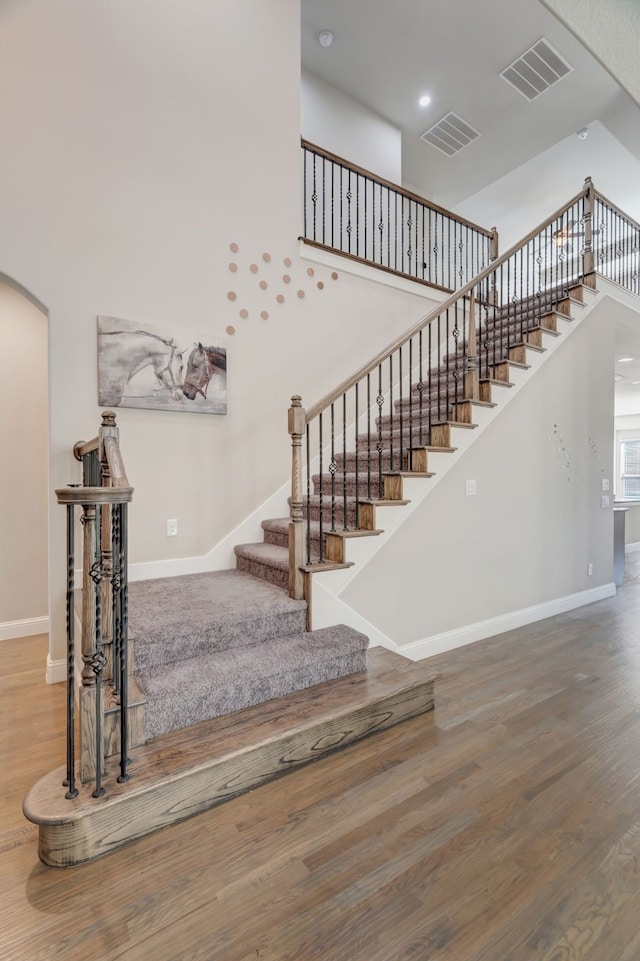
<box><xmin>137</xmin><ymin>624</ymin><xmax>369</xmax><ymax>739</ymax></box>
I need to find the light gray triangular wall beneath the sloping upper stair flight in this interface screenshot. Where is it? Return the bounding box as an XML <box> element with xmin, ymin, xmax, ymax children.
<box><xmin>341</xmin><ymin>301</ymin><xmax>616</xmax><ymax>650</ymax></box>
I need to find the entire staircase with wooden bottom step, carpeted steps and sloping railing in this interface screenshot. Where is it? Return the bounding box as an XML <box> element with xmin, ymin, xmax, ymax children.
<box><xmin>24</xmin><ymin>171</ymin><xmax>636</xmax><ymax>866</ymax></box>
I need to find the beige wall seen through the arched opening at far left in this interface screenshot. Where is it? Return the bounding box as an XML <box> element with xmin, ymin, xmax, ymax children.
<box><xmin>0</xmin><ymin>281</ymin><xmax>49</xmax><ymax>636</ymax></box>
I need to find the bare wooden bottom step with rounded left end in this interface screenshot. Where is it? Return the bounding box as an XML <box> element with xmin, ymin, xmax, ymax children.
<box><xmin>23</xmin><ymin>648</ymin><xmax>437</xmax><ymax>867</ymax></box>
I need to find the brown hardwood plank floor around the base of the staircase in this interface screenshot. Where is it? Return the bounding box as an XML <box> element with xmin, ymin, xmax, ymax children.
<box><xmin>0</xmin><ymin>555</ymin><xmax>640</xmax><ymax>961</ymax></box>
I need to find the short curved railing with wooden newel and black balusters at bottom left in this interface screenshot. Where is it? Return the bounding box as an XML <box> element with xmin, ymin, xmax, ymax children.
<box><xmin>56</xmin><ymin>411</ymin><xmax>133</xmax><ymax>798</ymax></box>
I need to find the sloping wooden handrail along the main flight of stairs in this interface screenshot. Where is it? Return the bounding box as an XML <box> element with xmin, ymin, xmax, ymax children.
<box><xmin>305</xmin><ymin>185</ymin><xmax>588</xmax><ymax>424</ymax></box>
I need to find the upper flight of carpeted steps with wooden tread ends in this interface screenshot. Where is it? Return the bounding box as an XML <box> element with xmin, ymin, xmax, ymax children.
<box><xmin>234</xmin><ymin>276</ymin><xmax>595</xmax><ymax>588</ymax></box>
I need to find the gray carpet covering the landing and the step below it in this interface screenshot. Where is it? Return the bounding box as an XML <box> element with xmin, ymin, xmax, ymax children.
<box><xmin>129</xmin><ymin>570</ymin><xmax>369</xmax><ymax>739</ymax></box>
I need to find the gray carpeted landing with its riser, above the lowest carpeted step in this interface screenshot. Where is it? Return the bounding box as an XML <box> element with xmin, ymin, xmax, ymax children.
<box><xmin>129</xmin><ymin>570</ymin><xmax>307</xmax><ymax>675</ymax></box>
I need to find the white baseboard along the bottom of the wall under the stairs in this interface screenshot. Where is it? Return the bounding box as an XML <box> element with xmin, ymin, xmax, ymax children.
<box><xmin>395</xmin><ymin>582</ymin><xmax>616</xmax><ymax>661</ymax></box>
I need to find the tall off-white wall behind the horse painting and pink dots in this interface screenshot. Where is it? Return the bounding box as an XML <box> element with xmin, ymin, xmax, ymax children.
<box><xmin>0</xmin><ymin>0</ymin><xmax>436</xmax><ymax>676</ymax></box>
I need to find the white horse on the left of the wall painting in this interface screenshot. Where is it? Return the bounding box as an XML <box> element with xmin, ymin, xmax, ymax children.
<box><xmin>98</xmin><ymin>329</ymin><xmax>183</xmax><ymax>407</ymax></box>
